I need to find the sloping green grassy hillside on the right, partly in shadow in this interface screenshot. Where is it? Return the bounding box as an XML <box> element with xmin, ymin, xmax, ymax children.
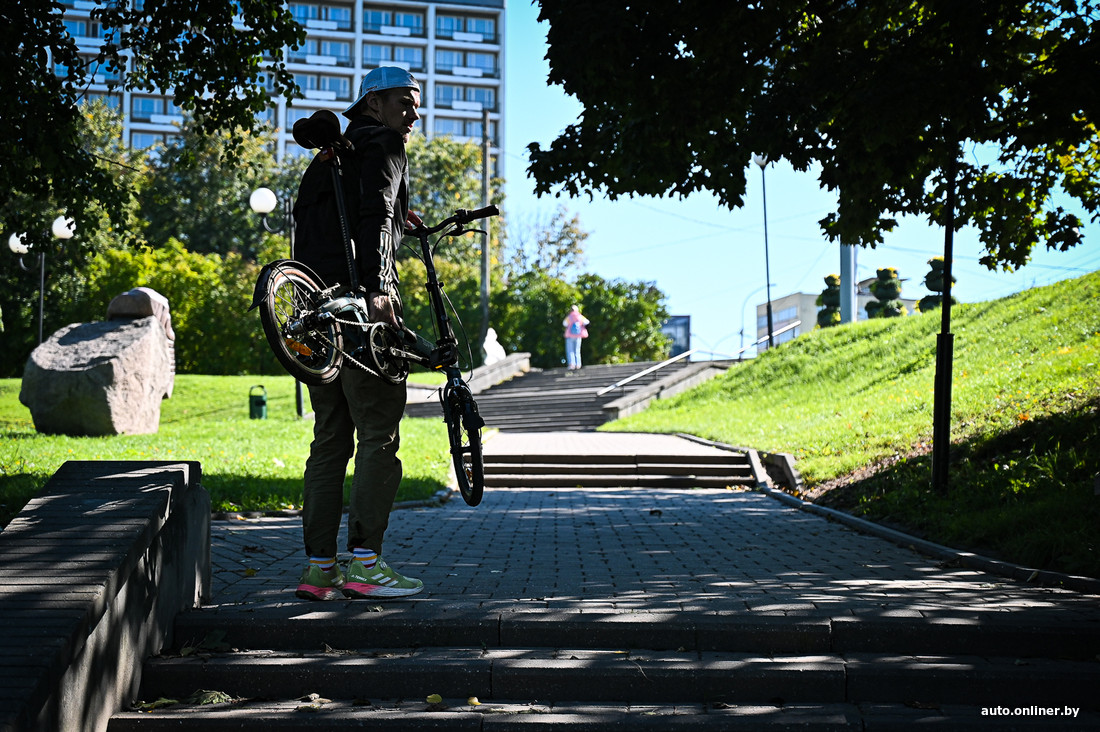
<box><xmin>605</xmin><ymin>272</ymin><xmax>1100</xmax><ymax>577</ymax></box>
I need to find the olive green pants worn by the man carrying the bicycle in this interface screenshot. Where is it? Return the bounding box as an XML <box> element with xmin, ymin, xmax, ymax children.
<box><xmin>301</xmin><ymin>368</ymin><xmax>406</xmax><ymax>557</ymax></box>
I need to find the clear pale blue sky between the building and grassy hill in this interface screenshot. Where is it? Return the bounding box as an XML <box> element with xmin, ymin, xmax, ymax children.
<box><xmin>504</xmin><ymin>0</ymin><xmax>1100</xmax><ymax>354</ymax></box>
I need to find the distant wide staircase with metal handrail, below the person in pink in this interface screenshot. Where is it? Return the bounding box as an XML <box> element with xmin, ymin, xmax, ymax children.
<box><xmin>406</xmin><ymin>361</ymin><xmax>728</xmax><ymax>431</ymax></box>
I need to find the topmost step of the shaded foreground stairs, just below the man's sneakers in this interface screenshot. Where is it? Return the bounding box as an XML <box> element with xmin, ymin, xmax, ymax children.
<box><xmin>174</xmin><ymin>607</ymin><xmax>1100</xmax><ymax>660</ymax></box>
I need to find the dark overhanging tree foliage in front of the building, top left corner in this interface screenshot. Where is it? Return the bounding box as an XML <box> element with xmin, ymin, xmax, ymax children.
<box><xmin>0</xmin><ymin>0</ymin><xmax>305</xmax><ymax>250</ymax></box>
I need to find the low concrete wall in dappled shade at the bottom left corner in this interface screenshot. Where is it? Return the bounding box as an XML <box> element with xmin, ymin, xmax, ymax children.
<box><xmin>0</xmin><ymin>461</ymin><xmax>210</xmax><ymax>732</ymax></box>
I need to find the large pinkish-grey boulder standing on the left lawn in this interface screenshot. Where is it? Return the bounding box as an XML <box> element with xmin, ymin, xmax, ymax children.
<box><xmin>19</xmin><ymin>316</ymin><xmax>175</xmax><ymax>435</ymax></box>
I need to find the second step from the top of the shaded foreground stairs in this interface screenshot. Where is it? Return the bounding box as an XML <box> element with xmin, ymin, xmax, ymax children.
<box><xmin>130</xmin><ymin>647</ymin><xmax>1100</xmax><ymax>707</ymax></box>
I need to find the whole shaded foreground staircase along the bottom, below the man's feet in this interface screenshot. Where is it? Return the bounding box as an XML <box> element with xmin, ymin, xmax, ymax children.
<box><xmin>108</xmin><ymin>602</ymin><xmax>1100</xmax><ymax>732</ymax></box>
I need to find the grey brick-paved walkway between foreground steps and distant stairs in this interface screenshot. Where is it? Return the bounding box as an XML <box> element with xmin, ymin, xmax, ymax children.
<box><xmin>206</xmin><ymin>433</ymin><xmax>1100</xmax><ymax>623</ymax></box>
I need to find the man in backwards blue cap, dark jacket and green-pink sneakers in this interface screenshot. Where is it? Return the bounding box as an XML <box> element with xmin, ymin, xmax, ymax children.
<box><xmin>294</xmin><ymin>66</ymin><xmax>424</xmax><ymax>600</ymax></box>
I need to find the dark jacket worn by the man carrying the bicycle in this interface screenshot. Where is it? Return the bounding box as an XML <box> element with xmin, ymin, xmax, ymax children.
<box><xmin>294</xmin><ymin>117</ymin><xmax>409</xmax><ymax>298</ymax></box>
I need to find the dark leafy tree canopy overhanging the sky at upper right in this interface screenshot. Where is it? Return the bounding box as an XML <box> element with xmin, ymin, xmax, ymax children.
<box><xmin>529</xmin><ymin>0</ymin><xmax>1100</xmax><ymax>269</ymax></box>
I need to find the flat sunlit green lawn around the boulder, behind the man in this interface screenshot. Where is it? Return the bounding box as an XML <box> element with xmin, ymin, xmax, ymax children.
<box><xmin>0</xmin><ymin>374</ymin><xmax>449</xmax><ymax>526</ymax></box>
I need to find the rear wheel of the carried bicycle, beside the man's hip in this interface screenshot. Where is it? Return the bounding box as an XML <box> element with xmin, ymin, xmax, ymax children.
<box><xmin>260</xmin><ymin>263</ymin><xmax>343</xmax><ymax>386</ymax></box>
